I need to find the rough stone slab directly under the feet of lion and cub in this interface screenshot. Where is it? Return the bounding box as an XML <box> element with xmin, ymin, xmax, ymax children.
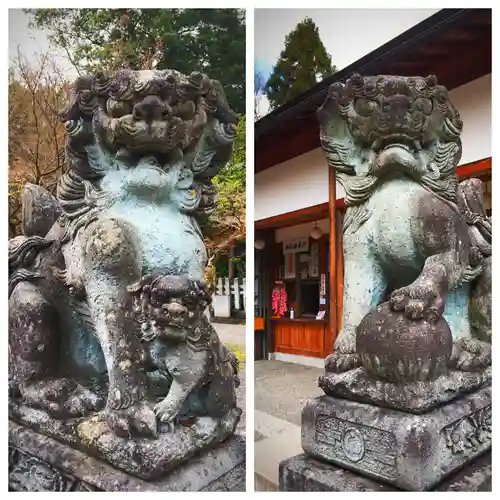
<box><xmin>9</xmin><ymin>402</ymin><xmax>241</xmax><ymax>480</ymax></box>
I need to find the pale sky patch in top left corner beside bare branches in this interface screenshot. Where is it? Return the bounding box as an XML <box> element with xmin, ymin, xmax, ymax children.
<box><xmin>9</xmin><ymin>9</ymin><xmax>78</xmax><ymax>79</ymax></box>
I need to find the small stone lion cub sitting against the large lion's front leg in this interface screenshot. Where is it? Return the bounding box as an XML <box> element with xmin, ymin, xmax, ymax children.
<box><xmin>128</xmin><ymin>275</ymin><xmax>240</xmax><ymax>429</ymax></box>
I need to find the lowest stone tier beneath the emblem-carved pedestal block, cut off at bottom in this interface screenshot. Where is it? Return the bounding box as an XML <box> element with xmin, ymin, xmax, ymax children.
<box><xmin>279</xmin><ymin>452</ymin><xmax>492</xmax><ymax>492</ymax></box>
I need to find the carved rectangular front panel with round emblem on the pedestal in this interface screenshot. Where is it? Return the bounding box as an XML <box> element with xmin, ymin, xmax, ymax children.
<box><xmin>315</xmin><ymin>414</ymin><xmax>396</xmax><ymax>480</ymax></box>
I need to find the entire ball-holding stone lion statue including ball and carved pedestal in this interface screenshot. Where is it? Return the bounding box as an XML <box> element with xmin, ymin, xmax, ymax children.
<box><xmin>290</xmin><ymin>75</ymin><xmax>492</xmax><ymax>491</ymax></box>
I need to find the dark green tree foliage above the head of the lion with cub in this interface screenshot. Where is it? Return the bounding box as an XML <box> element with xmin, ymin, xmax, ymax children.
<box><xmin>27</xmin><ymin>9</ymin><xmax>245</xmax><ymax>113</ymax></box>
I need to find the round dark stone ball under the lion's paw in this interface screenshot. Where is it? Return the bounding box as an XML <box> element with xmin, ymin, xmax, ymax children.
<box><xmin>356</xmin><ymin>302</ymin><xmax>453</xmax><ymax>383</ymax></box>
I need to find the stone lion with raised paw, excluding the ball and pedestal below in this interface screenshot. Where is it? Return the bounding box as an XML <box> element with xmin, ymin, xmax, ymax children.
<box><xmin>318</xmin><ymin>74</ymin><xmax>491</xmax><ymax>371</ymax></box>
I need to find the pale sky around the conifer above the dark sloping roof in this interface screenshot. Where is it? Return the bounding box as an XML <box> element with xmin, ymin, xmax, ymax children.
<box><xmin>255</xmin><ymin>8</ymin><xmax>440</xmax><ymax>115</ymax></box>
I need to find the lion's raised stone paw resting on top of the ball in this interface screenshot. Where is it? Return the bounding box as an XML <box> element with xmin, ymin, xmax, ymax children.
<box><xmin>390</xmin><ymin>285</ymin><xmax>444</xmax><ymax>322</ymax></box>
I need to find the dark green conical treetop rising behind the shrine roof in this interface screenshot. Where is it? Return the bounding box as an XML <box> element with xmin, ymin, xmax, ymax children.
<box><xmin>265</xmin><ymin>18</ymin><xmax>336</xmax><ymax>109</ymax></box>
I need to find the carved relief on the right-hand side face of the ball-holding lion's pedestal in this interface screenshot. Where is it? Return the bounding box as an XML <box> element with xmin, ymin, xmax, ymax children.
<box><xmin>441</xmin><ymin>405</ymin><xmax>491</xmax><ymax>454</ymax></box>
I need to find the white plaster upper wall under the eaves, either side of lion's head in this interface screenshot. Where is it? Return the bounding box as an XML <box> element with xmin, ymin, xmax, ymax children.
<box><xmin>255</xmin><ymin>75</ymin><xmax>492</xmax><ymax>220</ymax></box>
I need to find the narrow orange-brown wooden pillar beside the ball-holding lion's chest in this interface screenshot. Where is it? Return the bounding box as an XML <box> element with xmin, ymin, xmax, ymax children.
<box><xmin>325</xmin><ymin>167</ymin><xmax>338</xmax><ymax>353</ymax></box>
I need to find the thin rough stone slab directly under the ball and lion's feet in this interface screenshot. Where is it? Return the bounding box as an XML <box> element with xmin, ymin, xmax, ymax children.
<box><xmin>319</xmin><ymin>367</ymin><xmax>491</xmax><ymax>413</ymax></box>
